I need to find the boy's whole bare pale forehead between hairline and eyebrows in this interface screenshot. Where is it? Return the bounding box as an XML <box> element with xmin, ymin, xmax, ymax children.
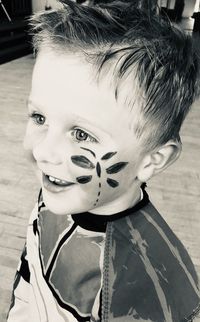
<box><xmin>30</xmin><ymin>51</ymin><xmax>144</xmax><ymax>143</ymax></box>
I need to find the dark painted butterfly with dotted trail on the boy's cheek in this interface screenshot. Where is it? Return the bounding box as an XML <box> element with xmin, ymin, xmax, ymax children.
<box><xmin>71</xmin><ymin>147</ymin><xmax>128</xmax><ymax>207</ymax></box>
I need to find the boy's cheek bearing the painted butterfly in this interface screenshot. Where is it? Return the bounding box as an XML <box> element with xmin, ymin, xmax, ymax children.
<box><xmin>71</xmin><ymin>147</ymin><xmax>134</xmax><ymax>206</ymax></box>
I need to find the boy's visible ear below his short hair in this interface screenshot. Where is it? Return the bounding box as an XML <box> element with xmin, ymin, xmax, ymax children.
<box><xmin>137</xmin><ymin>140</ymin><xmax>181</xmax><ymax>182</ymax></box>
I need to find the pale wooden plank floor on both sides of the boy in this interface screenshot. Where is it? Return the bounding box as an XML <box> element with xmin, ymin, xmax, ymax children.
<box><xmin>0</xmin><ymin>56</ymin><xmax>200</xmax><ymax>322</ymax></box>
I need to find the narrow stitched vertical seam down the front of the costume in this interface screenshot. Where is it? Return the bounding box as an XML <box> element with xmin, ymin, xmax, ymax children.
<box><xmin>101</xmin><ymin>222</ymin><xmax>113</xmax><ymax>322</ymax></box>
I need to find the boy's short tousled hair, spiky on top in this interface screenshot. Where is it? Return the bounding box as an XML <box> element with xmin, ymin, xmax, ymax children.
<box><xmin>31</xmin><ymin>0</ymin><xmax>199</xmax><ymax>150</ymax></box>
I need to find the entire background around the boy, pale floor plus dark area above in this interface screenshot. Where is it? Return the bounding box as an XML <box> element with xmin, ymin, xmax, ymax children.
<box><xmin>0</xmin><ymin>0</ymin><xmax>200</xmax><ymax>322</ymax></box>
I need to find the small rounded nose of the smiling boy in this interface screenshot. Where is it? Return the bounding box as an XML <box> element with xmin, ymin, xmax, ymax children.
<box><xmin>33</xmin><ymin>133</ymin><xmax>66</xmax><ymax>165</ymax></box>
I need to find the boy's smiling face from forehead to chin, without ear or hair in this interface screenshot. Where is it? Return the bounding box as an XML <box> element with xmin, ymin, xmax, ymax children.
<box><xmin>24</xmin><ymin>52</ymin><xmax>145</xmax><ymax>214</ymax></box>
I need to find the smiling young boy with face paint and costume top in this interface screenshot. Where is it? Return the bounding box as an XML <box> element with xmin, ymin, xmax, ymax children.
<box><xmin>8</xmin><ymin>1</ymin><xmax>200</xmax><ymax>322</ymax></box>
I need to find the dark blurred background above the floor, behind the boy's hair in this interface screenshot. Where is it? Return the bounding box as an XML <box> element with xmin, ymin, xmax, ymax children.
<box><xmin>0</xmin><ymin>0</ymin><xmax>200</xmax><ymax>63</ymax></box>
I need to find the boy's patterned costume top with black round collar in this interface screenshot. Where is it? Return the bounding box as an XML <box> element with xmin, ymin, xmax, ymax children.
<box><xmin>8</xmin><ymin>191</ymin><xmax>200</xmax><ymax>322</ymax></box>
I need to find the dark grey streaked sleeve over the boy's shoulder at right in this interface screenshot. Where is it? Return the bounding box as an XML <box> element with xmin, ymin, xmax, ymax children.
<box><xmin>108</xmin><ymin>203</ymin><xmax>199</xmax><ymax>322</ymax></box>
